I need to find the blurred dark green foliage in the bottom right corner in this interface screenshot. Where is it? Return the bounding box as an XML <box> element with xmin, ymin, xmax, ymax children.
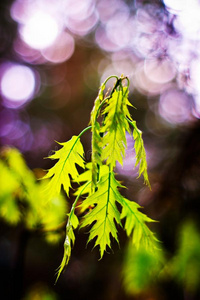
<box><xmin>122</xmin><ymin>220</ymin><xmax>200</xmax><ymax>295</ymax></box>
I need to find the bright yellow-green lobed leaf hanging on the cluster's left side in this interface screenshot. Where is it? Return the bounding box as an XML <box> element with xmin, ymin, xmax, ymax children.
<box><xmin>43</xmin><ymin>136</ymin><xmax>85</xmax><ymax>196</ymax></box>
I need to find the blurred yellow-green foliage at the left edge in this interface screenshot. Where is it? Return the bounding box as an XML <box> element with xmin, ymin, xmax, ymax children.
<box><xmin>0</xmin><ymin>147</ymin><xmax>67</xmax><ymax>242</ymax></box>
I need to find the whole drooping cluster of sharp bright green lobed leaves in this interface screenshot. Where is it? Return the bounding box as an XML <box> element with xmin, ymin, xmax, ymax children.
<box><xmin>44</xmin><ymin>76</ymin><xmax>157</xmax><ymax>279</ymax></box>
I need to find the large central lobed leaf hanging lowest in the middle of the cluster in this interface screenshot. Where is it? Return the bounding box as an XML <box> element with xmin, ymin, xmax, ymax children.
<box><xmin>81</xmin><ymin>166</ymin><xmax>121</xmax><ymax>258</ymax></box>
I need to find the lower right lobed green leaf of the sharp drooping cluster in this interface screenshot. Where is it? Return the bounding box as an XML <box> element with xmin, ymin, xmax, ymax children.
<box><xmin>121</xmin><ymin>198</ymin><xmax>158</xmax><ymax>250</ymax></box>
